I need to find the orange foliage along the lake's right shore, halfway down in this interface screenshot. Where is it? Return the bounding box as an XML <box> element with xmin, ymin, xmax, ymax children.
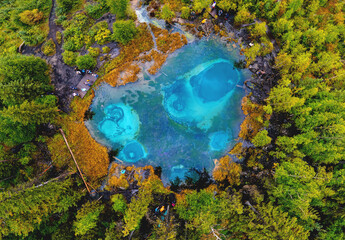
<box><xmin>239</xmin><ymin>97</ymin><xmax>270</xmax><ymax>140</ymax></box>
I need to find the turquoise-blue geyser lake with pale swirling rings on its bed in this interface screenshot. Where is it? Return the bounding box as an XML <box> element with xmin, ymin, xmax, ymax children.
<box><xmin>85</xmin><ymin>39</ymin><xmax>249</xmax><ymax>182</ymax></box>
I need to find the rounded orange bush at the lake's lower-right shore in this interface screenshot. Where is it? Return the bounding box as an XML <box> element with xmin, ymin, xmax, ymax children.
<box><xmin>212</xmin><ymin>156</ymin><xmax>242</xmax><ymax>185</ymax></box>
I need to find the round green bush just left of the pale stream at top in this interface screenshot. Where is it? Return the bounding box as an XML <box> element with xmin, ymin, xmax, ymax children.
<box><xmin>113</xmin><ymin>20</ymin><xmax>138</xmax><ymax>45</ymax></box>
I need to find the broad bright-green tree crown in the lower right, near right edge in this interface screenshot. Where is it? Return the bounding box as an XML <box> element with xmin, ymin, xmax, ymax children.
<box><xmin>269</xmin><ymin>158</ymin><xmax>334</xmax><ymax>228</ymax></box>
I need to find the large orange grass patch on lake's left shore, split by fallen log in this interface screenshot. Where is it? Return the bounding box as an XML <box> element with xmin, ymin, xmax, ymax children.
<box><xmin>49</xmin><ymin>94</ymin><xmax>109</xmax><ymax>181</ymax></box>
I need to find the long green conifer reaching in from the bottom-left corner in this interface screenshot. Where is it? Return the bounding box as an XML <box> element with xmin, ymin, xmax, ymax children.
<box><xmin>0</xmin><ymin>179</ymin><xmax>82</xmax><ymax>237</ymax></box>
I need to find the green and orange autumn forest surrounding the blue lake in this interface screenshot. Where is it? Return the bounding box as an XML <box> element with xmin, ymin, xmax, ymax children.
<box><xmin>0</xmin><ymin>0</ymin><xmax>345</xmax><ymax>240</ymax></box>
